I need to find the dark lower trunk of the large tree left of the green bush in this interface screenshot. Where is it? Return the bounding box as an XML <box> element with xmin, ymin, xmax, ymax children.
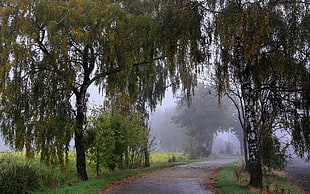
<box><xmin>75</xmin><ymin>90</ymin><xmax>88</xmax><ymax>181</ymax></box>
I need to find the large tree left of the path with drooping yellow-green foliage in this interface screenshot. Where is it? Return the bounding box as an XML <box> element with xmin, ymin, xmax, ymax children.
<box><xmin>0</xmin><ymin>0</ymin><xmax>202</xmax><ymax>181</ymax></box>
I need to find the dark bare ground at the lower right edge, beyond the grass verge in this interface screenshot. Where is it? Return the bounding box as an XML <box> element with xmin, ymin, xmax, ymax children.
<box><xmin>285</xmin><ymin>159</ymin><xmax>310</xmax><ymax>193</ymax></box>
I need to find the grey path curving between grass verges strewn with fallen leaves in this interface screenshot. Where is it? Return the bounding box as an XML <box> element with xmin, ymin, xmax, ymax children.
<box><xmin>104</xmin><ymin>156</ymin><xmax>238</xmax><ymax>194</ymax></box>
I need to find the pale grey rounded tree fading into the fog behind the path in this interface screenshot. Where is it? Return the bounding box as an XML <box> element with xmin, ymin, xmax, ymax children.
<box><xmin>173</xmin><ymin>84</ymin><xmax>238</xmax><ymax>157</ymax></box>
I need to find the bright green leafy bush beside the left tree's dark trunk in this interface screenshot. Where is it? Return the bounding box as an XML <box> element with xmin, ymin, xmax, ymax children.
<box><xmin>88</xmin><ymin>109</ymin><xmax>148</xmax><ymax>171</ymax></box>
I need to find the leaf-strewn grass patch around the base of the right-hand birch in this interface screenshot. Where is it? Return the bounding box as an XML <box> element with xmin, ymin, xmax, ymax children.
<box><xmin>213</xmin><ymin>160</ymin><xmax>302</xmax><ymax>194</ymax></box>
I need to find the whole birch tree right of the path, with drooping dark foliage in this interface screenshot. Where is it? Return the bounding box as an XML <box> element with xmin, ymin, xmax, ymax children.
<box><xmin>203</xmin><ymin>0</ymin><xmax>310</xmax><ymax>188</ymax></box>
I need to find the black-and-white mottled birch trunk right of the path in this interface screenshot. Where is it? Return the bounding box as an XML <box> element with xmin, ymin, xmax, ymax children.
<box><xmin>235</xmin><ymin>37</ymin><xmax>263</xmax><ymax>188</ymax></box>
